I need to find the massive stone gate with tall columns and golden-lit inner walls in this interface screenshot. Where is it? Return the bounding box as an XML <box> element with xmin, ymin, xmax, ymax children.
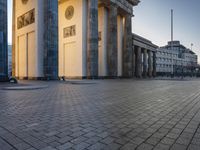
<box><xmin>0</xmin><ymin>0</ymin><xmax>159</xmax><ymax>79</ymax></box>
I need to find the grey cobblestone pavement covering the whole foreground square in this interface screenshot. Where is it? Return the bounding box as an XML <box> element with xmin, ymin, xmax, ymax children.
<box><xmin>0</xmin><ymin>80</ymin><xmax>200</xmax><ymax>150</ymax></box>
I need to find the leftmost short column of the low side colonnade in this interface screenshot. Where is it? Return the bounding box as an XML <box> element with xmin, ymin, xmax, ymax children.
<box><xmin>136</xmin><ymin>47</ymin><xmax>142</xmax><ymax>78</ymax></box>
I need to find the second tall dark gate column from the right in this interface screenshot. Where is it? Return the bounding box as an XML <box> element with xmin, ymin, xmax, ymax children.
<box><xmin>107</xmin><ymin>4</ymin><xmax>118</xmax><ymax>77</ymax></box>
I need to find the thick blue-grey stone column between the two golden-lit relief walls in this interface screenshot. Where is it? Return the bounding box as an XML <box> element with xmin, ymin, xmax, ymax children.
<box><xmin>44</xmin><ymin>0</ymin><xmax>58</xmax><ymax>79</ymax></box>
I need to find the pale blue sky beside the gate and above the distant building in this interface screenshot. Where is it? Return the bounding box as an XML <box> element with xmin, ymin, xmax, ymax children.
<box><xmin>8</xmin><ymin>0</ymin><xmax>200</xmax><ymax>60</ymax></box>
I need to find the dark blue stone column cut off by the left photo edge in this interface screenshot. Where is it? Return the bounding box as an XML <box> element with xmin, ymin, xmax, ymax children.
<box><xmin>0</xmin><ymin>0</ymin><xmax>8</xmax><ymax>81</ymax></box>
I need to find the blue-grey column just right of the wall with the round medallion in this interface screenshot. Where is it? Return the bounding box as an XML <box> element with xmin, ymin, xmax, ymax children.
<box><xmin>87</xmin><ymin>0</ymin><xmax>98</xmax><ymax>78</ymax></box>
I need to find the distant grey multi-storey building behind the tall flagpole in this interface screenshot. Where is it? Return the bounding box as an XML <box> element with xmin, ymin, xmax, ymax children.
<box><xmin>156</xmin><ymin>41</ymin><xmax>198</xmax><ymax>75</ymax></box>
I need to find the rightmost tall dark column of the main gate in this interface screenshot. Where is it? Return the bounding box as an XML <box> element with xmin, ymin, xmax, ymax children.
<box><xmin>123</xmin><ymin>14</ymin><xmax>133</xmax><ymax>77</ymax></box>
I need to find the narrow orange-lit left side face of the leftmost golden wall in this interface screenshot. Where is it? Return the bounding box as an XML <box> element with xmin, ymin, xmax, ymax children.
<box><xmin>12</xmin><ymin>0</ymin><xmax>16</xmax><ymax>76</ymax></box>
